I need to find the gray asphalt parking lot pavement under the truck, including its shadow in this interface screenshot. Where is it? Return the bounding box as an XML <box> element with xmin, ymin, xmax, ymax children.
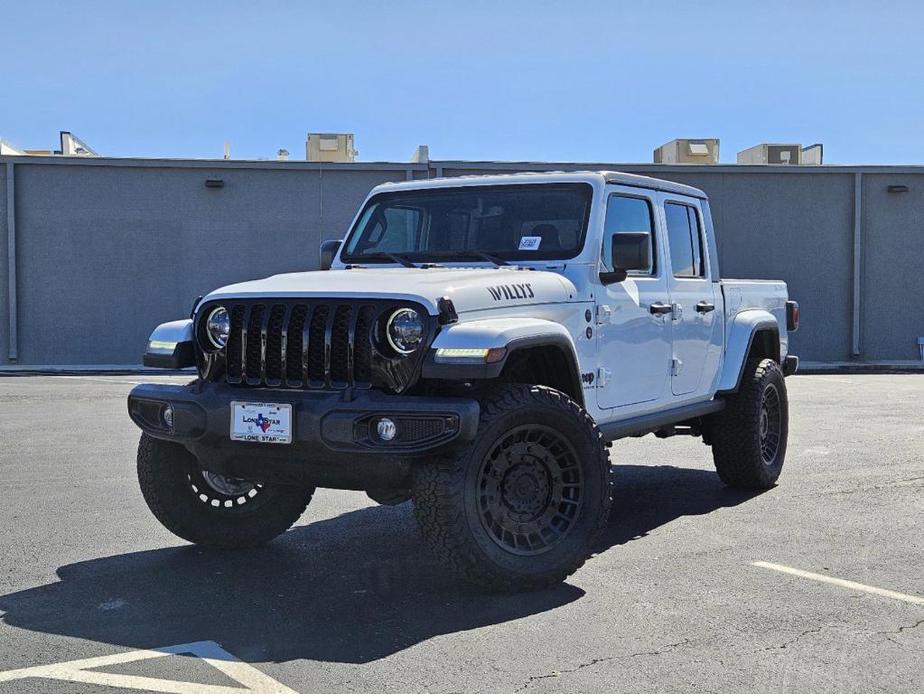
<box><xmin>0</xmin><ymin>375</ymin><xmax>924</xmax><ymax>694</ymax></box>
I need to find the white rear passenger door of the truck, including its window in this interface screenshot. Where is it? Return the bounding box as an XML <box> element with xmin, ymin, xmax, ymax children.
<box><xmin>660</xmin><ymin>194</ymin><xmax>722</xmax><ymax>396</ymax></box>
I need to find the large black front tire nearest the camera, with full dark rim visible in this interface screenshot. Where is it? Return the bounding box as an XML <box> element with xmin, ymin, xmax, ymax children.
<box><xmin>412</xmin><ymin>384</ymin><xmax>612</xmax><ymax>592</ymax></box>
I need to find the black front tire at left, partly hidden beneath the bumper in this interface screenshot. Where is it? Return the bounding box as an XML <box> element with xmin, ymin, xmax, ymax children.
<box><xmin>138</xmin><ymin>434</ymin><xmax>314</xmax><ymax>549</ymax></box>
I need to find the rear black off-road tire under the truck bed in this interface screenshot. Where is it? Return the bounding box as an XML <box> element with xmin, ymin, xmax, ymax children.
<box><xmin>709</xmin><ymin>359</ymin><xmax>789</xmax><ymax>489</ymax></box>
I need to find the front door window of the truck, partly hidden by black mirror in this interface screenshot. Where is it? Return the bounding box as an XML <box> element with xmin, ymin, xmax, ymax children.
<box><xmin>603</xmin><ymin>195</ymin><xmax>655</xmax><ymax>275</ymax></box>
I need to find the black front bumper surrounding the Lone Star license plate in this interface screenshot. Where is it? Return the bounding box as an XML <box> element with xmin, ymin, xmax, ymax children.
<box><xmin>128</xmin><ymin>383</ymin><xmax>479</xmax><ymax>489</ymax></box>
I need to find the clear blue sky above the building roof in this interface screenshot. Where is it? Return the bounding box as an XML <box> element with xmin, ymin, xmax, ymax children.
<box><xmin>0</xmin><ymin>0</ymin><xmax>924</xmax><ymax>164</ymax></box>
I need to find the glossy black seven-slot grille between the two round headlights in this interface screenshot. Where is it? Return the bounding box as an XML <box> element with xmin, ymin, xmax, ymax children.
<box><xmin>226</xmin><ymin>302</ymin><xmax>382</xmax><ymax>389</ymax></box>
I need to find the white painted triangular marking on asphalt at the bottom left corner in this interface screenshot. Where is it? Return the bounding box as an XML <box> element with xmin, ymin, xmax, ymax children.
<box><xmin>0</xmin><ymin>641</ymin><xmax>297</xmax><ymax>694</ymax></box>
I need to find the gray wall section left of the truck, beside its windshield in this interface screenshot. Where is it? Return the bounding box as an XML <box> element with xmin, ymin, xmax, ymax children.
<box><xmin>2</xmin><ymin>158</ymin><xmax>416</xmax><ymax>364</ymax></box>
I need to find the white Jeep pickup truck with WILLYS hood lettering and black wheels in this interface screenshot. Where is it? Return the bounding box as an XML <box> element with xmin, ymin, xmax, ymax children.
<box><xmin>128</xmin><ymin>172</ymin><xmax>799</xmax><ymax>590</ymax></box>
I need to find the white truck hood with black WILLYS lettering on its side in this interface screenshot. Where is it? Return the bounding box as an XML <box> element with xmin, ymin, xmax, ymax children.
<box><xmin>206</xmin><ymin>266</ymin><xmax>576</xmax><ymax>315</ymax></box>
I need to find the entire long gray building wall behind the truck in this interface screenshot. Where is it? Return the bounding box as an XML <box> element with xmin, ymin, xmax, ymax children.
<box><xmin>0</xmin><ymin>157</ymin><xmax>924</xmax><ymax>365</ymax></box>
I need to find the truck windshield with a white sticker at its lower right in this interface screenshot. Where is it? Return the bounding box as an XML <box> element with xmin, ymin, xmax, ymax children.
<box><xmin>341</xmin><ymin>183</ymin><xmax>593</xmax><ymax>263</ymax></box>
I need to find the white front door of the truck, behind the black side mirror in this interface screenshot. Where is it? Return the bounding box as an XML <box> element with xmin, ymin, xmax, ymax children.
<box><xmin>595</xmin><ymin>186</ymin><xmax>671</xmax><ymax>409</ymax></box>
